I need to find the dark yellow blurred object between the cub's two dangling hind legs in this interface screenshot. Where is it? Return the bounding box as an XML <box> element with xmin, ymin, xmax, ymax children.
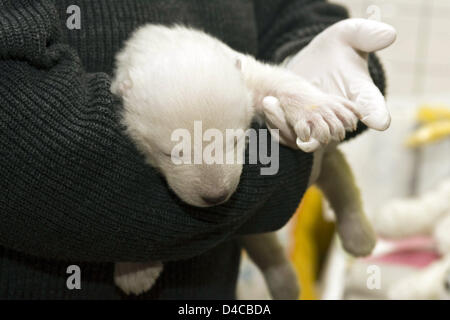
<box><xmin>290</xmin><ymin>186</ymin><xmax>334</xmax><ymax>300</ymax></box>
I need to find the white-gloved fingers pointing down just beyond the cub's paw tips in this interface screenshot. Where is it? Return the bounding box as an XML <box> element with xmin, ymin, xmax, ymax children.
<box><xmin>350</xmin><ymin>77</ymin><xmax>391</xmax><ymax>131</ymax></box>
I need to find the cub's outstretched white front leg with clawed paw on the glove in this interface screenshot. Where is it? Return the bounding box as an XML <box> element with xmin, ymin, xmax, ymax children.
<box><xmin>237</xmin><ymin>55</ymin><xmax>358</xmax><ymax>152</ymax></box>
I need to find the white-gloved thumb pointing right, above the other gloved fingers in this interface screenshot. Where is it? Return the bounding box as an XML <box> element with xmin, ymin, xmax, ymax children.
<box><xmin>340</xmin><ymin>18</ymin><xmax>397</xmax><ymax>52</ymax></box>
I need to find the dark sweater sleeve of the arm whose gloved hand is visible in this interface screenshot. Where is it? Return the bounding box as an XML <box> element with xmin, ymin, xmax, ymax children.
<box><xmin>255</xmin><ymin>0</ymin><xmax>386</xmax><ymax>140</ymax></box>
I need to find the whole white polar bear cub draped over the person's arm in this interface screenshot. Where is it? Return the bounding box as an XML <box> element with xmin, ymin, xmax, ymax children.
<box><xmin>111</xmin><ymin>24</ymin><xmax>374</xmax><ymax>299</ymax></box>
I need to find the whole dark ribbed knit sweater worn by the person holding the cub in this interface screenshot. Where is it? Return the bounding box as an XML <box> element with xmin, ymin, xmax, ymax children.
<box><xmin>0</xmin><ymin>0</ymin><xmax>384</xmax><ymax>299</ymax></box>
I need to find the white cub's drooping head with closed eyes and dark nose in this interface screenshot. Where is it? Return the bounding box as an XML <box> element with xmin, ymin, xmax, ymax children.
<box><xmin>112</xmin><ymin>49</ymin><xmax>253</xmax><ymax>207</ymax></box>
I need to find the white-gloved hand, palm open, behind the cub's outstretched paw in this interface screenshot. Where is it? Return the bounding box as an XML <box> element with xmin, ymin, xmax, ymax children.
<box><xmin>263</xmin><ymin>19</ymin><xmax>397</xmax><ymax>152</ymax></box>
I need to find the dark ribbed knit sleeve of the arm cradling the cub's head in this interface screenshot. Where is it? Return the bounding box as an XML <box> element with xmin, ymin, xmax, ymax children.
<box><xmin>0</xmin><ymin>0</ymin><xmax>310</xmax><ymax>261</ymax></box>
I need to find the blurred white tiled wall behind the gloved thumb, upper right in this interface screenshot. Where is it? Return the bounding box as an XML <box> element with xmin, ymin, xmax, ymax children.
<box><xmin>330</xmin><ymin>0</ymin><xmax>450</xmax><ymax>98</ymax></box>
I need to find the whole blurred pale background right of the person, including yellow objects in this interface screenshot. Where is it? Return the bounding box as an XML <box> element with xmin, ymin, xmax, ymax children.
<box><xmin>238</xmin><ymin>0</ymin><xmax>450</xmax><ymax>299</ymax></box>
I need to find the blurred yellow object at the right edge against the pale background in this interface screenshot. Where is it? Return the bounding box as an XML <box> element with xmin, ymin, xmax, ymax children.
<box><xmin>406</xmin><ymin>105</ymin><xmax>450</xmax><ymax>147</ymax></box>
